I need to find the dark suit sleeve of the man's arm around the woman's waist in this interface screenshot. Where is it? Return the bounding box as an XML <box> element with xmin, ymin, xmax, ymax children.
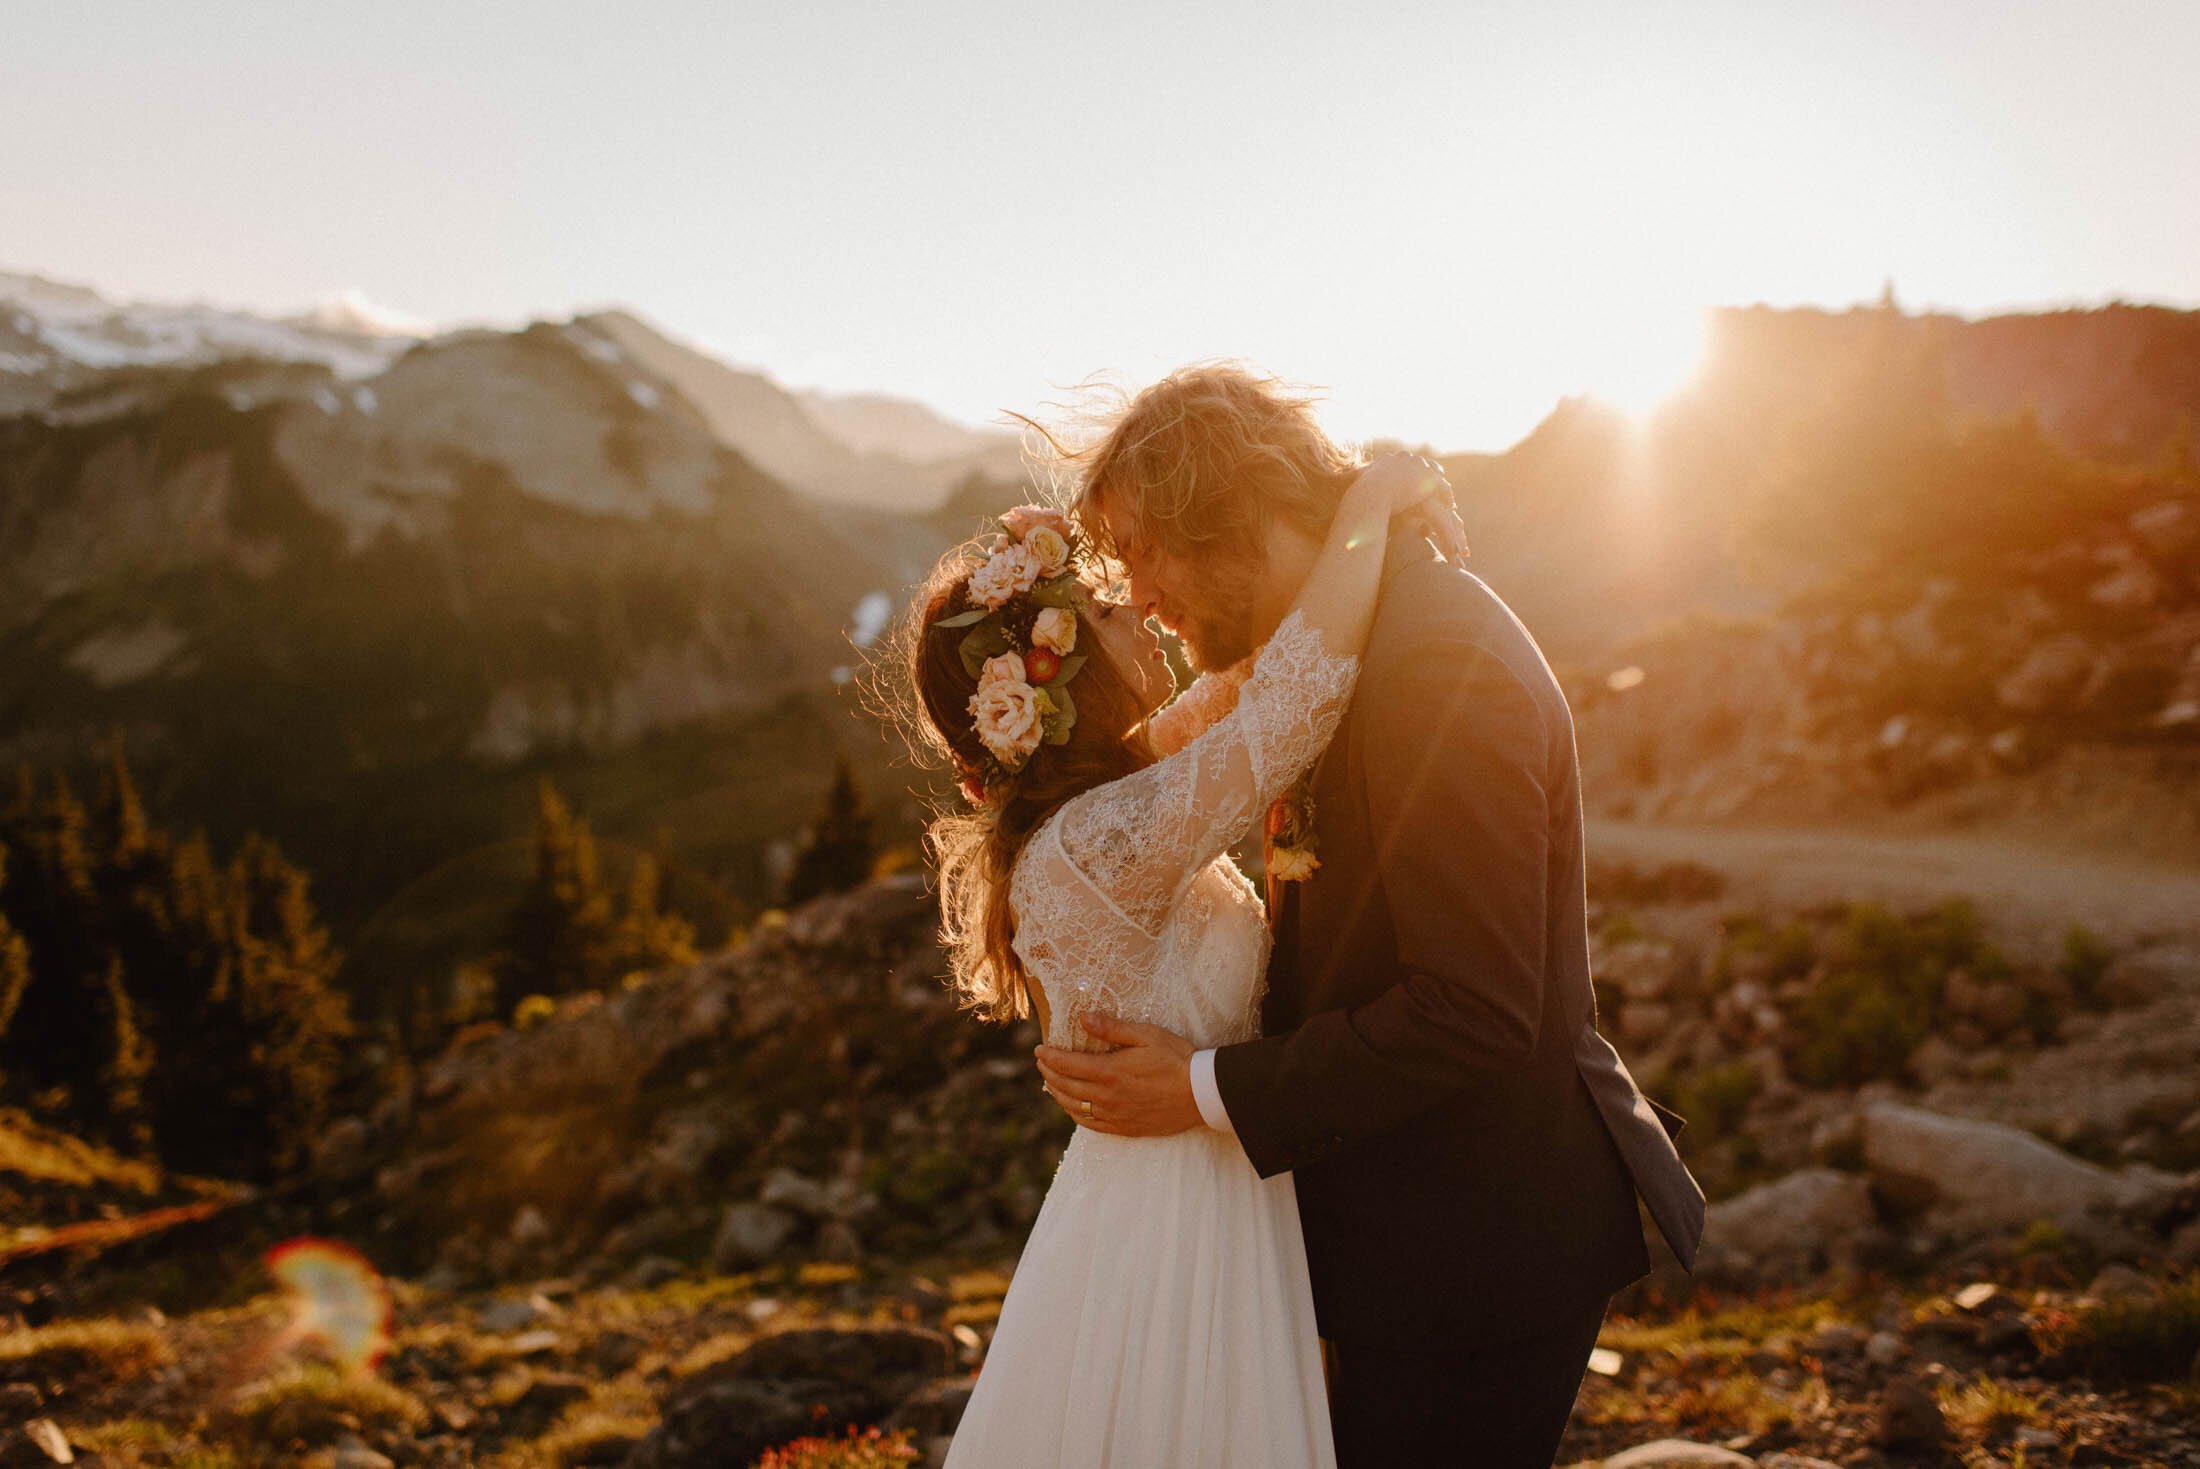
<box><xmin>1214</xmin><ymin>638</ymin><xmax>1551</xmax><ymax>1177</ymax></box>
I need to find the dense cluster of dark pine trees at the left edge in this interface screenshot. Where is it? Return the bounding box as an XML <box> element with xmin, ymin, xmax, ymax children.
<box><xmin>0</xmin><ymin>743</ymin><xmax>350</xmax><ymax>1179</ymax></box>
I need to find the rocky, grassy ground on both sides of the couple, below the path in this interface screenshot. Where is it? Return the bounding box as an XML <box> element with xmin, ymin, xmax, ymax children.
<box><xmin>0</xmin><ymin>842</ymin><xmax>2200</xmax><ymax>1469</ymax></box>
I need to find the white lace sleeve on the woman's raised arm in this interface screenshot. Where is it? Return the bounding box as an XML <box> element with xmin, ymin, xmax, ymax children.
<box><xmin>1060</xmin><ymin>611</ymin><xmax>1360</xmax><ymax>935</ymax></box>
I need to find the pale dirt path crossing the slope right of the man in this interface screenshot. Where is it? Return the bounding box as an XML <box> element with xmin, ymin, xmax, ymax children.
<box><xmin>1588</xmin><ymin>820</ymin><xmax>2200</xmax><ymax>946</ymax></box>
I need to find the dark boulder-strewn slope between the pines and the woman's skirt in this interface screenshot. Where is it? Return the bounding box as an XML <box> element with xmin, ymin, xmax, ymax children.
<box><xmin>349</xmin><ymin>875</ymin><xmax>1069</xmax><ymax>1278</ymax></box>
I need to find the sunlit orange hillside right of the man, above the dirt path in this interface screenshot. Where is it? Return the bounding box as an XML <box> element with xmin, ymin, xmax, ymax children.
<box><xmin>1454</xmin><ymin>308</ymin><xmax>2200</xmax><ymax>855</ymax></box>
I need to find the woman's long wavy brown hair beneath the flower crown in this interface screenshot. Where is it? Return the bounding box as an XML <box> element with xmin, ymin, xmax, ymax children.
<box><xmin>873</xmin><ymin>548</ymin><xmax>1155</xmax><ymax>1020</ymax></box>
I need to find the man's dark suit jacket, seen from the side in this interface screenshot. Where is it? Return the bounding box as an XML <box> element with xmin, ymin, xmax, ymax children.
<box><xmin>1214</xmin><ymin>534</ymin><xmax>1703</xmax><ymax>1350</ymax></box>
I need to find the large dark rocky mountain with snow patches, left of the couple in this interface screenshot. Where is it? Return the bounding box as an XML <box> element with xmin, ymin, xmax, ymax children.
<box><xmin>0</xmin><ymin>292</ymin><xmax>981</xmax><ymax>1014</ymax></box>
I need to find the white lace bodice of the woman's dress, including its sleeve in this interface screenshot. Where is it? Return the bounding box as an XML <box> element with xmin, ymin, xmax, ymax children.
<box><xmin>1010</xmin><ymin>611</ymin><xmax>1360</xmax><ymax>1049</ymax></box>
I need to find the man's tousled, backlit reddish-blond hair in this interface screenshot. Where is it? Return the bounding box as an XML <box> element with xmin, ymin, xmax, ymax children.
<box><xmin>1030</xmin><ymin>361</ymin><xmax>1364</xmax><ymax>592</ymax></box>
